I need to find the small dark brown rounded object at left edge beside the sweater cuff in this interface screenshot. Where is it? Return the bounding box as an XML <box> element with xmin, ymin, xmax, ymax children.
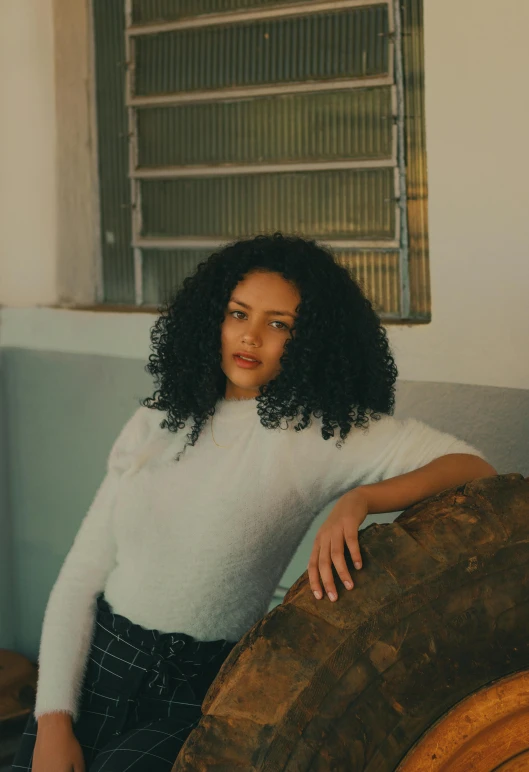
<box><xmin>0</xmin><ymin>649</ymin><xmax>37</xmax><ymax>722</ymax></box>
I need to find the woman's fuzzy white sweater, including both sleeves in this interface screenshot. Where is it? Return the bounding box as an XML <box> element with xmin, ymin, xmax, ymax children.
<box><xmin>35</xmin><ymin>399</ymin><xmax>481</xmax><ymax>717</ymax></box>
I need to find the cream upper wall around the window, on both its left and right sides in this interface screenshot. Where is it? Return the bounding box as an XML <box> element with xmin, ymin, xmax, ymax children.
<box><xmin>0</xmin><ymin>0</ymin><xmax>529</xmax><ymax>389</ymax></box>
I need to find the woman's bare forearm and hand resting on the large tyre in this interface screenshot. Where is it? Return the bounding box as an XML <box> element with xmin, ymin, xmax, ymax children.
<box><xmin>308</xmin><ymin>453</ymin><xmax>496</xmax><ymax>601</ymax></box>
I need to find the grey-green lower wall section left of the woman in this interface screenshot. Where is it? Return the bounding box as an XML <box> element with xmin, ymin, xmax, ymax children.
<box><xmin>5</xmin><ymin>349</ymin><xmax>150</xmax><ymax>657</ymax></box>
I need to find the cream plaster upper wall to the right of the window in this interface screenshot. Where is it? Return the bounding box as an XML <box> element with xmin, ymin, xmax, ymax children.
<box><xmin>390</xmin><ymin>0</ymin><xmax>529</xmax><ymax>389</ymax></box>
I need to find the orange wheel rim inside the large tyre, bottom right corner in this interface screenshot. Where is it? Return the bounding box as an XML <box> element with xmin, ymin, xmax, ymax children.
<box><xmin>397</xmin><ymin>670</ymin><xmax>529</xmax><ymax>772</ymax></box>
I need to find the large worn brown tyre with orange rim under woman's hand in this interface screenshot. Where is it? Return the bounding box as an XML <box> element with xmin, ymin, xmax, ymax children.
<box><xmin>173</xmin><ymin>474</ymin><xmax>529</xmax><ymax>772</ymax></box>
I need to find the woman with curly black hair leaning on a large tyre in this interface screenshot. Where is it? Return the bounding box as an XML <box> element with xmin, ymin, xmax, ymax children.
<box><xmin>13</xmin><ymin>234</ymin><xmax>495</xmax><ymax>772</ymax></box>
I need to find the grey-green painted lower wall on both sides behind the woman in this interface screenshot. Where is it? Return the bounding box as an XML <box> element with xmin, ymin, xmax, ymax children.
<box><xmin>0</xmin><ymin>348</ymin><xmax>529</xmax><ymax>657</ymax></box>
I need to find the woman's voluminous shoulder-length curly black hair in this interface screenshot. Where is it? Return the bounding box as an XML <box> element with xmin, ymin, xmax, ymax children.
<box><xmin>141</xmin><ymin>233</ymin><xmax>397</xmax><ymax>459</ymax></box>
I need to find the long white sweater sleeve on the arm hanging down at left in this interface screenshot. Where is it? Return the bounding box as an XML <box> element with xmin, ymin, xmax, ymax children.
<box><xmin>35</xmin><ymin>407</ymin><xmax>148</xmax><ymax>720</ymax></box>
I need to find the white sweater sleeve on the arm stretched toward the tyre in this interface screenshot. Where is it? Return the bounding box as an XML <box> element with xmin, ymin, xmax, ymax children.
<box><xmin>301</xmin><ymin>415</ymin><xmax>484</xmax><ymax>512</ymax></box>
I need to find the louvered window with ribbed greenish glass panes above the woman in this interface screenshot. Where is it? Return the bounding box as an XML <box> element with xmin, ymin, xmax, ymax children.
<box><xmin>94</xmin><ymin>0</ymin><xmax>429</xmax><ymax>320</ymax></box>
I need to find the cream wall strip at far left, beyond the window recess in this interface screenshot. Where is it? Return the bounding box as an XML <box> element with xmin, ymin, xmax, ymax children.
<box><xmin>0</xmin><ymin>0</ymin><xmax>57</xmax><ymax>306</ymax></box>
